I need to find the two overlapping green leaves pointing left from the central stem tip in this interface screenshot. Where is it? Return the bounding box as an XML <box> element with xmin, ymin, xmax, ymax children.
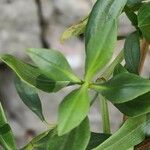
<box><xmin>0</xmin><ymin>49</ymin><xmax>81</xmax><ymax>92</ymax></box>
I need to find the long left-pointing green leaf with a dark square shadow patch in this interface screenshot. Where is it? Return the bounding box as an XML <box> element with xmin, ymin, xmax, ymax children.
<box><xmin>0</xmin><ymin>55</ymin><xmax>73</xmax><ymax>92</ymax></box>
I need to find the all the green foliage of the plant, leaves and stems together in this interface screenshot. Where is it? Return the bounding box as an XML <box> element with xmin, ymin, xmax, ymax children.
<box><xmin>0</xmin><ymin>0</ymin><xmax>150</xmax><ymax>150</ymax></box>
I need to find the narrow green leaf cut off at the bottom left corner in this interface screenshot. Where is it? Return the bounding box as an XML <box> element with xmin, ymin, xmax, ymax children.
<box><xmin>0</xmin><ymin>104</ymin><xmax>17</xmax><ymax>150</ymax></box>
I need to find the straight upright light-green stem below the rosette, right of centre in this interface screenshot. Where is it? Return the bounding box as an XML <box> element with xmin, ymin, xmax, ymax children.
<box><xmin>99</xmin><ymin>96</ymin><xmax>111</xmax><ymax>134</ymax></box>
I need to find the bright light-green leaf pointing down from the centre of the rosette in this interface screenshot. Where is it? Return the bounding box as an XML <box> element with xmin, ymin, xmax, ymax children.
<box><xmin>58</xmin><ymin>85</ymin><xmax>90</xmax><ymax>135</ymax></box>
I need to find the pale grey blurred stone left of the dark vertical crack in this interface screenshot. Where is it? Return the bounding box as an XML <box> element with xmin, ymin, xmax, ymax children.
<box><xmin>0</xmin><ymin>0</ymin><xmax>41</xmax><ymax>57</ymax></box>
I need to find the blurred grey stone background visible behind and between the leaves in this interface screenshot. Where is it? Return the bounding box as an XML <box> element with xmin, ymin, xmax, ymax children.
<box><xmin>0</xmin><ymin>0</ymin><xmax>150</xmax><ymax>147</ymax></box>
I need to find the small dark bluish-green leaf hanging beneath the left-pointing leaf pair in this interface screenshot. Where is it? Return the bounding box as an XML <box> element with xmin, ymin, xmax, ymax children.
<box><xmin>15</xmin><ymin>77</ymin><xmax>45</xmax><ymax>121</ymax></box>
